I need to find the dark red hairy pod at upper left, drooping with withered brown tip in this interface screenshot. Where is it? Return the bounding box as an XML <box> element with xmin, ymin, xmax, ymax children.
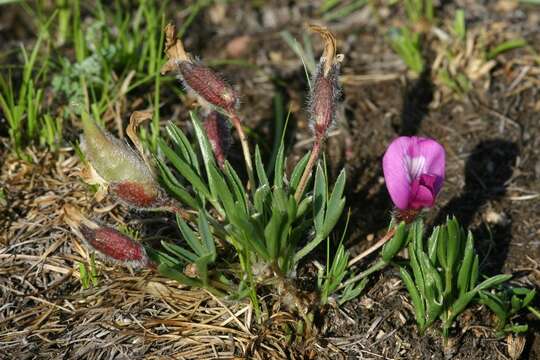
<box><xmin>177</xmin><ymin>61</ymin><xmax>238</xmax><ymax>110</ymax></box>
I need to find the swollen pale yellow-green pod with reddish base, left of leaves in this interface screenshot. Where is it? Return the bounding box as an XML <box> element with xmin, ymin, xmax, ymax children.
<box><xmin>81</xmin><ymin>114</ymin><xmax>164</xmax><ymax>208</ymax></box>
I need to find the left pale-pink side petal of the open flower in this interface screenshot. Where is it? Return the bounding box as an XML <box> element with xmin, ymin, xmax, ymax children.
<box><xmin>383</xmin><ymin>136</ymin><xmax>411</xmax><ymax>210</ymax></box>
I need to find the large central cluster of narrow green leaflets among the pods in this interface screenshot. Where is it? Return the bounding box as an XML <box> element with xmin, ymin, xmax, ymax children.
<box><xmin>150</xmin><ymin>113</ymin><xmax>347</xmax><ymax>310</ymax></box>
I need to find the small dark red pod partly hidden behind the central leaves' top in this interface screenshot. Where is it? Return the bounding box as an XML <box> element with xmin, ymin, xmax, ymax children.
<box><xmin>200</xmin><ymin>111</ymin><xmax>231</xmax><ymax>168</ymax></box>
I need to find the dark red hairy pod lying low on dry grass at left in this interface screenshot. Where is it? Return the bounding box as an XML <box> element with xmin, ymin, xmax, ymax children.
<box><xmin>80</xmin><ymin>225</ymin><xmax>152</xmax><ymax>268</ymax></box>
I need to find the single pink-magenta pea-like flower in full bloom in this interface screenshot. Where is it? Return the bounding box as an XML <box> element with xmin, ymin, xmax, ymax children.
<box><xmin>383</xmin><ymin>136</ymin><xmax>445</xmax><ymax>210</ymax></box>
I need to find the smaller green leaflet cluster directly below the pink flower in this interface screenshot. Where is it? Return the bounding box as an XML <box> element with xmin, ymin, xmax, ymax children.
<box><xmin>400</xmin><ymin>218</ymin><xmax>511</xmax><ymax>338</ymax></box>
